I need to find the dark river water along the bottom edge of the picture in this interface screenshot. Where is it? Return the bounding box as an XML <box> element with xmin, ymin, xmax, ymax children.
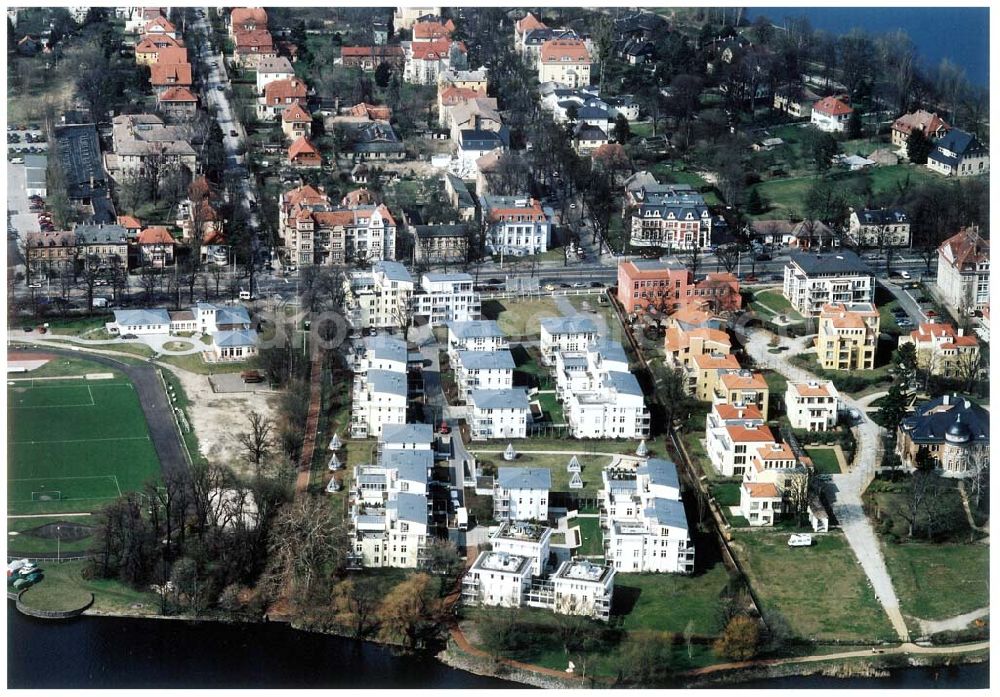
<box><xmin>7</xmin><ymin>603</ymin><xmax>989</xmax><ymax>689</ymax></box>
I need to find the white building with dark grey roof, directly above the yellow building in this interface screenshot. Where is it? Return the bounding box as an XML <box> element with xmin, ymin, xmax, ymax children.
<box><xmin>783</xmin><ymin>250</ymin><xmax>875</xmax><ymax>316</ymax></box>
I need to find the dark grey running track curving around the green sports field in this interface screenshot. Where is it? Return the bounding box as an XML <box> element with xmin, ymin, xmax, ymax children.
<box><xmin>13</xmin><ymin>339</ymin><xmax>190</xmax><ymax>478</ymax></box>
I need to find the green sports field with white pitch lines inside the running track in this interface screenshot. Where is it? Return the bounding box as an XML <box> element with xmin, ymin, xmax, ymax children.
<box><xmin>7</xmin><ymin>367</ymin><xmax>160</xmax><ymax>515</ymax></box>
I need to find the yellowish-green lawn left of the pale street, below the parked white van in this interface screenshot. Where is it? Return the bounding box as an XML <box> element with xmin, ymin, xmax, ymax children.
<box><xmin>733</xmin><ymin>532</ymin><xmax>895</xmax><ymax>641</ymax></box>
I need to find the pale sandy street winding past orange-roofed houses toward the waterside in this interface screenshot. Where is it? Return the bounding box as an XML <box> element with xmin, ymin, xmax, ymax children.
<box><xmin>746</xmin><ymin>329</ymin><xmax>909</xmax><ymax>642</ymax></box>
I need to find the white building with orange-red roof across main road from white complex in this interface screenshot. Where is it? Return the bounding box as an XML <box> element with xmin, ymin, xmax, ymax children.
<box><xmin>479</xmin><ymin>194</ymin><xmax>553</xmax><ymax>256</ymax></box>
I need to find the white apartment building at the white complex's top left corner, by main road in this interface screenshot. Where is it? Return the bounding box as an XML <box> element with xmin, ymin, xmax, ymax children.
<box><xmin>344</xmin><ymin>261</ymin><xmax>414</xmax><ymax>328</ymax></box>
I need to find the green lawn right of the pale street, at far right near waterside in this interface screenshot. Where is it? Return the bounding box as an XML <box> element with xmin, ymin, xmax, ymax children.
<box><xmin>882</xmin><ymin>542</ymin><xmax>990</xmax><ymax>620</ymax></box>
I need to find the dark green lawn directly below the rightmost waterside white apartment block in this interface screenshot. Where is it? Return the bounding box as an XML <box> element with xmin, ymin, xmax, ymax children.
<box><xmin>613</xmin><ymin>561</ymin><xmax>729</xmax><ymax>636</ymax></box>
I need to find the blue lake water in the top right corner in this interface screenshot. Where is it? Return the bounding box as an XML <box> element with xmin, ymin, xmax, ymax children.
<box><xmin>747</xmin><ymin>7</ymin><xmax>990</xmax><ymax>85</ymax></box>
